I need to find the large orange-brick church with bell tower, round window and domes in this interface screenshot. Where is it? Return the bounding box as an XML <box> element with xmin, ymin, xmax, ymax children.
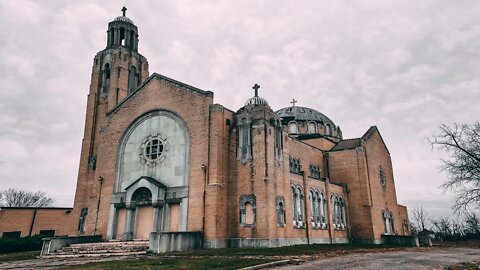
<box><xmin>0</xmin><ymin>12</ymin><xmax>410</xmax><ymax>248</ymax></box>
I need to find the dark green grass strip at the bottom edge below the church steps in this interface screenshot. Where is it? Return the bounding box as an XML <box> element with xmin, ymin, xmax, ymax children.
<box><xmin>68</xmin><ymin>258</ymin><xmax>274</xmax><ymax>270</ymax></box>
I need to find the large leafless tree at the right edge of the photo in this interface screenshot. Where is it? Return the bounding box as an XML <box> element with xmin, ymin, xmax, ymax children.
<box><xmin>429</xmin><ymin>121</ymin><xmax>480</xmax><ymax>212</ymax></box>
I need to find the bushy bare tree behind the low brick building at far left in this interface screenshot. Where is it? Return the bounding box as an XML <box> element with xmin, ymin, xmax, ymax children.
<box><xmin>0</xmin><ymin>188</ymin><xmax>55</xmax><ymax>207</ymax></box>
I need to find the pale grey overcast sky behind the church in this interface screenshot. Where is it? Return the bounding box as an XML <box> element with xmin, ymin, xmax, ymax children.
<box><xmin>0</xmin><ymin>0</ymin><xmax>480</xmax><ymax>219</ymax></box>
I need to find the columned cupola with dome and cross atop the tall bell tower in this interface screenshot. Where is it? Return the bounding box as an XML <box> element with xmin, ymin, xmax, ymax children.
<box><xmin>107</xmin><ymin>7</ymin><xmax>138</xmax><ymax>51</ymax></box>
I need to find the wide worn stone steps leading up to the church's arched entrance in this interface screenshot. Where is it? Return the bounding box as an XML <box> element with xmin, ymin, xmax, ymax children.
<box><xmin>43</xmin><ymin>241</ymin><xmax>148</xmax><ymax>258</ymax></box>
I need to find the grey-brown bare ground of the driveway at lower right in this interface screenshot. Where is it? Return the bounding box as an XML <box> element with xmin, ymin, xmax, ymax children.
<box><xmin>275</xmin><ymin>248</ymin><xmax>480</xmax><ymax>270</ymax></box>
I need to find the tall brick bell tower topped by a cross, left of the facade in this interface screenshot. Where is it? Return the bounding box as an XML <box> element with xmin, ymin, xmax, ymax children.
<box><xmin>73</xmin><ymin>7</ymin><xmax>149</xmax><ymax>234</ymax></box>
